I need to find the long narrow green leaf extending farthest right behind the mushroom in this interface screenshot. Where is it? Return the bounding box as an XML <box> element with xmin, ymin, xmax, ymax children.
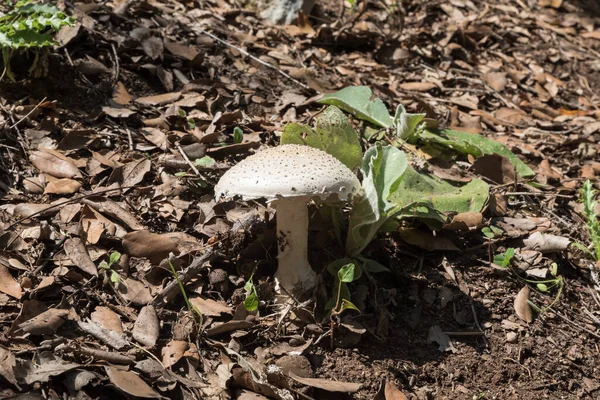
<box><xmin>418</xmin><ymin>129</ymin><xmax>535</xmax><ymax>178</ymax></box>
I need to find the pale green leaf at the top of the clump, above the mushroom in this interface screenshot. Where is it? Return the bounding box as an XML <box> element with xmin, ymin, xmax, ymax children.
<box><xmin>318</xmin><ymin>86</ymin><xmax>392</xmax><ymax>128</ymax></box>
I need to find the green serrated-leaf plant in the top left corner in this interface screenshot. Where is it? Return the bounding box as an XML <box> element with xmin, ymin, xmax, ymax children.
<box><xmin>0</xmin><ymin>1</ymin><xmax>74</xmax><ymax>81</ymax></box>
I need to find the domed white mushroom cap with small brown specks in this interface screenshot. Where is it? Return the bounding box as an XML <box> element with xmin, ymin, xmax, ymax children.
<box><xmin>215</xmin><ymin>144</ymin><xmax>361</xmax><ymax>201</ymax></box>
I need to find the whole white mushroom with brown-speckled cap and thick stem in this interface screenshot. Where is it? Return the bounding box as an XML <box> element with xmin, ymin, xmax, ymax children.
<box><xmin>215</xmin><ymin>144</ymin><xmax>360</xmax><ymax>297</ymax></box>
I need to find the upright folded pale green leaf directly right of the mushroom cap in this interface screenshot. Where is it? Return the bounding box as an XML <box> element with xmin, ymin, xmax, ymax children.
<box><xmin>346</xmin><ymin>144</ymin><xmax>408</xmax><ymax>256</ymax></box>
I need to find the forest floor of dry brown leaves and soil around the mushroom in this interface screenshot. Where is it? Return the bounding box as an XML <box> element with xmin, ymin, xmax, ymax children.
<box><xmin>0</xmin><ymin>0</ymin><xmax>600</xmax><ymax>400</ymax></box>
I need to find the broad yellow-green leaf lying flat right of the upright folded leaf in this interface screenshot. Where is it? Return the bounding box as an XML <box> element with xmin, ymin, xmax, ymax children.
<box><xmin>388</xmin><ymin>166</ymin><xmax>489</xmax><ymax>228</ymax></box>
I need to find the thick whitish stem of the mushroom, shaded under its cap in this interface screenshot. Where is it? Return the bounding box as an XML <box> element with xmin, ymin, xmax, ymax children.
<box><xmin>272</xmin><ymin>198</ymin><xmax>317</xmax><ymax>297</ymax></box>
